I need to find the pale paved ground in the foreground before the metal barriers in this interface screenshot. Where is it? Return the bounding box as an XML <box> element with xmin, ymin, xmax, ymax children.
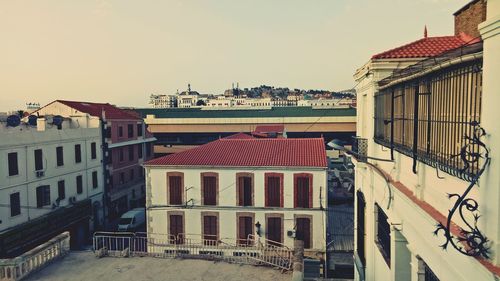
<box><xmin>25</xmin><ymin>251</ymin><xmax>292</xmax><ymax>281</ymax></box>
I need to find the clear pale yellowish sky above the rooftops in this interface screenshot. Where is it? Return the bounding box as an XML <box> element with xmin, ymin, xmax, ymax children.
<box><xmin>0</xmin><ymin>0</ymin><xmax>468</xmax><ymax>111</ymax></box>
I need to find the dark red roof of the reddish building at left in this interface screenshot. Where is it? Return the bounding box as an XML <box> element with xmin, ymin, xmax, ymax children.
<box><xmin>56</xmin><ymin>100</ymin><xmax>140</xmax><ymax>120</ymax></box>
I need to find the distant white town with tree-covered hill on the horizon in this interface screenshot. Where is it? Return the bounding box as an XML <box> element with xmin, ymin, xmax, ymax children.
<box><xmin>149</xmin><ymin>84</ymin><xmax>356</xmax><ymax>109</ymax></box>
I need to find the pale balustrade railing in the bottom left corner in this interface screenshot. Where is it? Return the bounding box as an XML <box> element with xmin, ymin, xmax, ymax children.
<box><xmin>0</xmin><ymin>232</ymin><xmax>70</xmax><ymax>281</ymax></box>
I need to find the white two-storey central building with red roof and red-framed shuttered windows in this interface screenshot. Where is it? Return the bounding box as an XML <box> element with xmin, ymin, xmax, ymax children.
<box><xmin>144</xmin><ymin>135</ymin><xmax>327</xmax><ymax>258</ymax></box>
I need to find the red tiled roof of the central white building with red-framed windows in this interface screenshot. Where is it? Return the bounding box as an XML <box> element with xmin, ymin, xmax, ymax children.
<box><xmin>145</xmin><ymin>138</ymin><xmax>327</xmax><ymax>168</ymax></box>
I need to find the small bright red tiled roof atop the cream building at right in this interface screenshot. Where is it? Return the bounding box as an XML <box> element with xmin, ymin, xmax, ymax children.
<box><xmin>372</xmin><ymin>34</ymin><xmax>472</xmax><ymax>59</ymax></box>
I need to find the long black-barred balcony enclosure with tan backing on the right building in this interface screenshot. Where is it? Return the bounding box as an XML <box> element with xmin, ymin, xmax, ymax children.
<box><xmin>374</xmin><ymin>59</ymin><xmax>482</xmax><ymax>181</ymax></box>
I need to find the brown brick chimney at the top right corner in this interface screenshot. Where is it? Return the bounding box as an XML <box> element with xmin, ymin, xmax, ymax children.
<box><xmin>453</xmin><ymin>0</ymin><xmax>486</xmax><ymax>38</ymax></box>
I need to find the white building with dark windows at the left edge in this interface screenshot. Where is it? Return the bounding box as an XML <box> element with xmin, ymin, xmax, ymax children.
<box><xmin>0</xmin><ymin>116</ymin><xmax>104</xmax><ymax>257</ymax></box>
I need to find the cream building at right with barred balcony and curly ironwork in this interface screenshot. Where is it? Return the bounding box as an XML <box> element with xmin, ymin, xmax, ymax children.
<box><xmin>353</xmin><ymin>0</ymin><xmax>500</xmax><ymax>281</ymax></box>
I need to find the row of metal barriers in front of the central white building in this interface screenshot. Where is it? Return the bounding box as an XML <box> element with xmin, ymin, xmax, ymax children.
<box><xmin>93</xmin><ymin>232</ymin><xmax>293</xmax><ymax>270</ymax></box>
